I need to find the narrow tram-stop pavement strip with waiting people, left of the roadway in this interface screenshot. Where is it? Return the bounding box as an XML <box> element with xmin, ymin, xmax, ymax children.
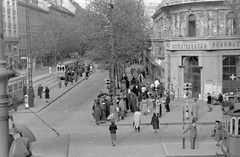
<box><xmin>13</xmin><ymin>71</ymin><xmax>95</xmax><ymax>114</ymax></box>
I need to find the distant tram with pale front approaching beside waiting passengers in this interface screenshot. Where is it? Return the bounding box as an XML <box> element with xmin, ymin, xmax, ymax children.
<box><xmin>56</xmin><ymin>58</ymin><xmax>84</xmax><ymax>80</ymax></box>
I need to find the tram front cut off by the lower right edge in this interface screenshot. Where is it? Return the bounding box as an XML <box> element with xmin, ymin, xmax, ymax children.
<box><xmin>221</xmin><ymin>96</ymin><xmax>240</xmax><ymax>157</ymax></box>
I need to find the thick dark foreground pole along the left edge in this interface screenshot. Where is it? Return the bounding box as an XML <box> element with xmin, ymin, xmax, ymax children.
<box><xmin>0</xmin><ymin>1</ymin><xmax>14</xmax><ymax>157</ymax></box>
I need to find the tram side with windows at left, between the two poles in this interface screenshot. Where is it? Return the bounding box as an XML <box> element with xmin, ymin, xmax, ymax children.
<box><xmin>7</xmin><ymin>75</ymin><xmax>27</xmax><ymax>105</ymax></box>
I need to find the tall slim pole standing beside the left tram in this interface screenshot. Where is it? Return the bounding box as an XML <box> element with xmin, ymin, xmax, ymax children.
<box><xmin>26</xmin><ymin>0</ymin><xmax>34</xmax><ymax>107</ymax></box>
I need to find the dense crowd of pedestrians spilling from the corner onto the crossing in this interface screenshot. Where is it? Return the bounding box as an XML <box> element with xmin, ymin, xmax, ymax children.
<box><xmin>92</xmin><ymin>68</ymin><xmax>173</xmax><ymax>145</ymax></box>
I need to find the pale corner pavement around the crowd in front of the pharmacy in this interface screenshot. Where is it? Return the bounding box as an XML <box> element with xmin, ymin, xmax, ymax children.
<box><xmin>102</xmin><ymin>64</ymin><xmax>222</xmax><ymax>125</ymax></box>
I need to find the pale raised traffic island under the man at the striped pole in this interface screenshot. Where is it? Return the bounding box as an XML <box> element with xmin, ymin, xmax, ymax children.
<box><xmin>162</xmin><ymin>142</ymin><xmax>219</xmax><ymax>157</ymax></box>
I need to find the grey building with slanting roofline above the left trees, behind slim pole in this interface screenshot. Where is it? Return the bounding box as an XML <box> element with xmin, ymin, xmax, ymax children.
<box><xmin>17</xmin><ymin>0</ymin><xmax>76</xmax><ymax>69</ymax></box>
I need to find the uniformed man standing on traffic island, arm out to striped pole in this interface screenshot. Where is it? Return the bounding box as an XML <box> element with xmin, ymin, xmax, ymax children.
<box><xmin>183</xmin><ymin>120</ymin><xmax>197</xmax><ymax>149</ymax></box>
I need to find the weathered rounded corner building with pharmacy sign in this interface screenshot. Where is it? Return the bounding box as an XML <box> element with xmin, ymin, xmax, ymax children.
<box><xmin>151</xmin><ymin>0</ymin><xmax>240</xmax><ymax>98</ymax></box>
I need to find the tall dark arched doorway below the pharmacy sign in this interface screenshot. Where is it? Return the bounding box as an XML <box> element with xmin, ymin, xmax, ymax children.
<box><xmin>182</xmin><ymin>56</ymin><xmax>201</xmax><ymax>97</ymax></box>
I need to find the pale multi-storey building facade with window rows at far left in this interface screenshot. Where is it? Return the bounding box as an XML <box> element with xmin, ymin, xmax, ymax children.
<box><xmin>2</xmin><ymin>0</ymin><xmax>19</xmax><ymax>66</ymax></box>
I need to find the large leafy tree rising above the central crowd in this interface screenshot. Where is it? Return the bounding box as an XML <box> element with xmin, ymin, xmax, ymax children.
<box><xmin>85</xmin><ymin>0</ymin><xmax>149</xmax><ymax>63</ymax></box>
